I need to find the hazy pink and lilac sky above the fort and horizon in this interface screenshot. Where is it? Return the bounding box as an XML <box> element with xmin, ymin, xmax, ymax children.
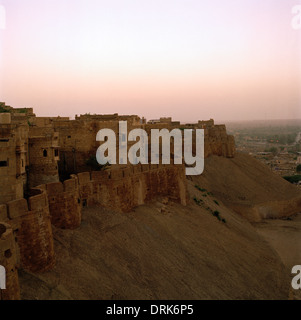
<box><xmin>0</xmin><ymin>0</ymin><xmax>301</xmax><ymax>121</ymax></box>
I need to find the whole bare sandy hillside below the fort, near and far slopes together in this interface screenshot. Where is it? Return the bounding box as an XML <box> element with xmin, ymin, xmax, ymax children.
<box><xmin>20</xmin><ymin>155</ymin><xmax>300</xmax><ymax>299</ymax></box>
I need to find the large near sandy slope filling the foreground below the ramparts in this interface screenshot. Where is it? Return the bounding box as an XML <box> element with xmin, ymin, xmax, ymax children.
<box><xmin>21</xmin><ymin>200</ymin><xmax>289</xmax><ymax>299</ymax></box>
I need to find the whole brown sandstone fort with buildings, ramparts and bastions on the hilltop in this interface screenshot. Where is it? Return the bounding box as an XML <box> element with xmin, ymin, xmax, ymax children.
<box><xmin>0</xmin><ymin>103</ymin><xmax>235</xmax><ymax>300</ymax></box>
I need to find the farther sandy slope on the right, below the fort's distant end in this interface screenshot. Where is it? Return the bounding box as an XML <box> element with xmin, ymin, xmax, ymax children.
<box><xmin>192</xmin><ymin>153</ymin><xmax>301</xmax><ymax>221</ymax></box>
